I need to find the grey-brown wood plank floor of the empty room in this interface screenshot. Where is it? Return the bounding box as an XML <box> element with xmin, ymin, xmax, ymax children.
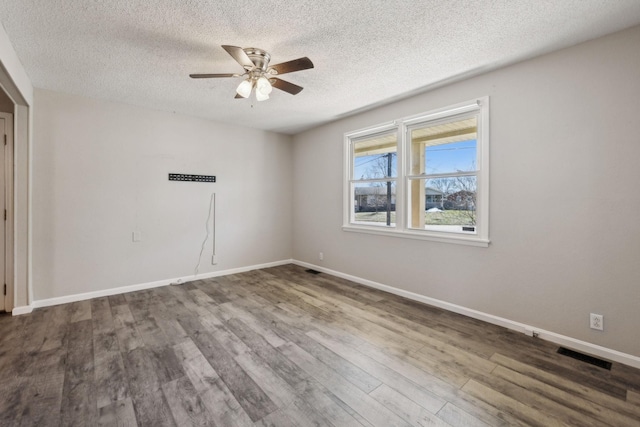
<box><xmin>0</xmin><ymin>265</ymin><xmax>640</xmax><ymax>427</ymax></box>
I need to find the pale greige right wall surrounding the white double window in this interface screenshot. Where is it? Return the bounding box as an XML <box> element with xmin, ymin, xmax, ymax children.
<box><xmin>293</xmin><ymin>27</ymin><xmax>640</xmax><ymax>356</ymax></box>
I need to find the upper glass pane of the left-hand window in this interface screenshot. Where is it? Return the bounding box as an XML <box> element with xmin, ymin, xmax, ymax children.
<box><xmin>352</xmin><ymin>133</ymin><xmax>398</xmax><ymax>179</ymax></box>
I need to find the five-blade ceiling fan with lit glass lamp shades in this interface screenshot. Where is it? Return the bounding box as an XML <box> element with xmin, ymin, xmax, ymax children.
<box><xmin>189</xmin><ymin>45</ymin><xmax>313</xmax><ymax>101</ymax></box>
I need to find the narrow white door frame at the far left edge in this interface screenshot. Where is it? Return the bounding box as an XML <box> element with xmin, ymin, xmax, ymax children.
<box><xmin>0</xmin><ymin>112</ymin><xmax>15</xmax><ymax>313</ymax></box>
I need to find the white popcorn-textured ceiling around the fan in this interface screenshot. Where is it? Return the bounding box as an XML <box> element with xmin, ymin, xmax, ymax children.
<box><xmin>0</xmin><ymin>0</ymin><xmax>640</xmax><ymax>133</ymax></box>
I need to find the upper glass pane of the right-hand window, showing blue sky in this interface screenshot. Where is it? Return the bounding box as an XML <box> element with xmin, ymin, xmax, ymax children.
<box><xmin>411</xmin><ymin>117</ymin><xmax>478</xmax><ymax>175</ymax></box>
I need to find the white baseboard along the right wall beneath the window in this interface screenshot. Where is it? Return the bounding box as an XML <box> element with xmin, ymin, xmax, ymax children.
<box><xmin>293</xmin><ymin>260</ymin><xmax>640</xmax><ymax>368</ymax></box>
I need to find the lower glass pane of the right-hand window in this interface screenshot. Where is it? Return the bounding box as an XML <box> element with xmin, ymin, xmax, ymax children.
<box><xmin>409</xmin><ymin>176</ymin><xmax>478</xmax><ymax>233</ymax></box>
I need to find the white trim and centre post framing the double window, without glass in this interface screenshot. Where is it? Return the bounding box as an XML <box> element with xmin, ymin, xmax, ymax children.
<box><xmin>342</xmin><ymin>96</ymin><xmax>490</xmax><ymax>247</ymax></box>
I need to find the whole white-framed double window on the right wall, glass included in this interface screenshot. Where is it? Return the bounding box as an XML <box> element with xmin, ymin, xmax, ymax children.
<box><xmin>343</xmin><ymin>97</ymin><xmax>489</xmax><ymax>246</ymax></box>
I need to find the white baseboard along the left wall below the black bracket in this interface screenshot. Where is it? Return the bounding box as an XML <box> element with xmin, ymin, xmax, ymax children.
<box><xmin>27</xmin><ymin>259</ymin><xmax>293</xmax><ymax>315</ymax></box>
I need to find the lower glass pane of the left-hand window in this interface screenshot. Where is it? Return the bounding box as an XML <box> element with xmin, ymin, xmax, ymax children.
<box><xmin>353</xmin><ymin>181</ymin><xmax>396</xmax><ymax>227</ymax></box>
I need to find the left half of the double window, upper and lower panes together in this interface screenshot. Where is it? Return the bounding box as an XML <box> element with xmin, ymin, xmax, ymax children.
<box><xmin>349</xmin><ymin>131</ymin><xmax>398</xmax><ymax>227</ymax></box>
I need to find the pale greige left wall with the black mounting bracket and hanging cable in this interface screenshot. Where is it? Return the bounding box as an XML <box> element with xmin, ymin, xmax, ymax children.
<box><xmin>33</xmin><ymin>89</ymin><xmax>292</xmax><ymax>300</ymax></box>
